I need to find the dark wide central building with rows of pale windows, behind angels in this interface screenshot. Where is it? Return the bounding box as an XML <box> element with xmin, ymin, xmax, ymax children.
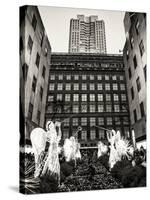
<box><xmin>45</xmin><ymin>53</ymin><xmax>130</xmax><ymax>146</ymax></box>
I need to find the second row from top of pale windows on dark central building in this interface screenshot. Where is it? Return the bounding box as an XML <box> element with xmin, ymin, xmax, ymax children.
<box><xmin>49</xmin><ymin>83</ymin><xmax>126</xmax><ymax>91</ymax></box>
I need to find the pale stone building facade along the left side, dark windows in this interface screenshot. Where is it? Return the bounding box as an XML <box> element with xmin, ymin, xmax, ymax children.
<box><xmin>20</xmin><ymin>6</ymin><xmax>51</xmax><ymax>139</ymax></box>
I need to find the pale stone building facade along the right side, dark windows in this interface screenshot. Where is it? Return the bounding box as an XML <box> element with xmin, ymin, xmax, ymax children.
<box><xmin>123</xmin><ymin>12</ymin><xmax>147</xmax><ymax>146</ymax></box>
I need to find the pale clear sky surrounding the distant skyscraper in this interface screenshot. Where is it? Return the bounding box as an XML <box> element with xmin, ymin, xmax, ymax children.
<box><xmin>38</xmin><ymin>6</ymin><xmax>125</xmax><ymax>54</ymax></box>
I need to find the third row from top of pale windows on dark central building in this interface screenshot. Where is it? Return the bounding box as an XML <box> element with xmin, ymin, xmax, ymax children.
<box><xmin>48</xmin><ymin>94</ymin><xmax>127</xmax><ymax>102</ymax></box>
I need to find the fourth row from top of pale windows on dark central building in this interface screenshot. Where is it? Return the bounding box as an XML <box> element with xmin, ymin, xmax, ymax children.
<box><xmin>47</xmin><ymin>104</ymin><xmax>128</xmax><ymax>114</ymax></box>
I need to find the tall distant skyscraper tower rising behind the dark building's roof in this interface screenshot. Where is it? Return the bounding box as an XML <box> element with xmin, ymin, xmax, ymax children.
<box><xmin>69</xmin><ymin>15</ymin><xmax>106</xmax><ymax>54</ymax></box>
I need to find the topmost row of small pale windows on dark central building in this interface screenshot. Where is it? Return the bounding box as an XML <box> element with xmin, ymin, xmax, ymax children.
<box><xmin>50</xmin><ymin>74</ymin><xmax>124</xmax><ymax>81</ymax></box>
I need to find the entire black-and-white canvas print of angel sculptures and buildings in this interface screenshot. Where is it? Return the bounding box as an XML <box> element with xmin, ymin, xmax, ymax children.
<box><xmin>19</xmin><ymin>5</ymin><xmax>147</xmax><ymax>194</ymax></box>
